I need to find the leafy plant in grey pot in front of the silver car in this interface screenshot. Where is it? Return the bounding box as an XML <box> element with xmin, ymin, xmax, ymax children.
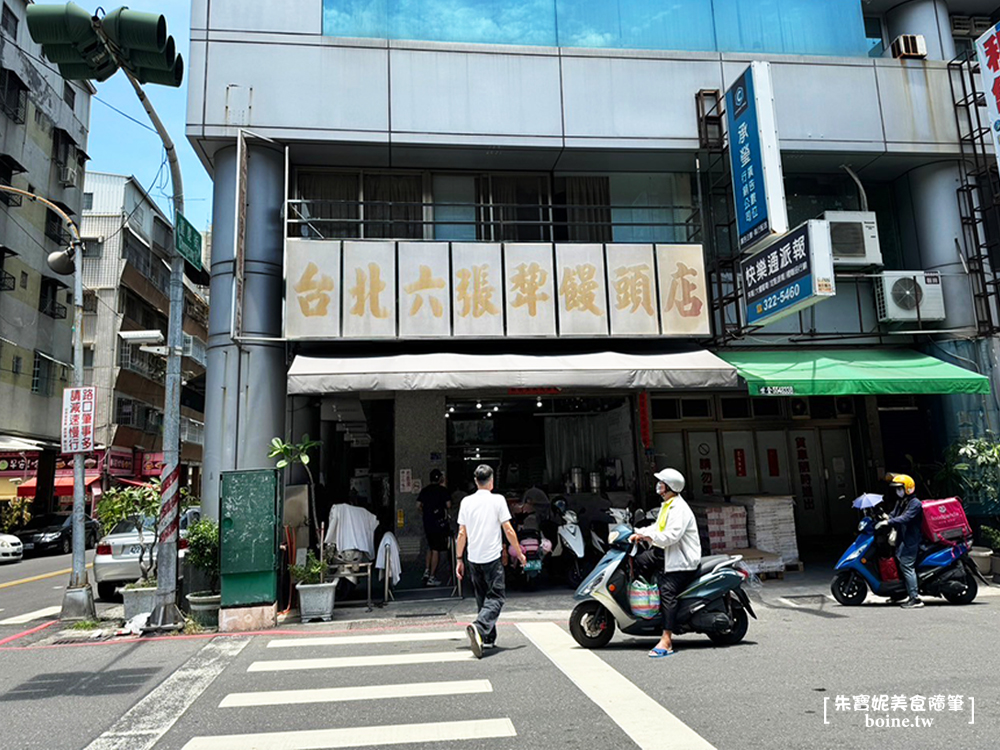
<box><xmin>97</xmin><ymin>485</ymin><xmax>160</xmax><ymax>620</ymax></box>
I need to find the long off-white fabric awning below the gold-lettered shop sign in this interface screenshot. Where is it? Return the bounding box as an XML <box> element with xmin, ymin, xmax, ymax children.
<box><xmin>288</xmin><ymin>349</ymin><xmax>737</xmax><ymax>395</ymax></box>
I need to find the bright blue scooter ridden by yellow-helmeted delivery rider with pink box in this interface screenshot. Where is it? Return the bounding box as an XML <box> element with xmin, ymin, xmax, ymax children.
<box><xmin>830</xmin><ymin>514</ymin><xmax>989</xmax><ymax>607</ymax></box>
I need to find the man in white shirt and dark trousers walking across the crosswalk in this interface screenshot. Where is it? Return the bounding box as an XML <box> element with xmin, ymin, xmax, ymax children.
<box><xmin>455</xmin><ymin>464</ymin><xmax>527</xmax><ymax>659</ymax></box>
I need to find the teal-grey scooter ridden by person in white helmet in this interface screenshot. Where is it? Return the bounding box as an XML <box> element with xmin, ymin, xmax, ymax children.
<box><xmin>569</xmin><ymin>511</ymin><xmax>757</xmax><ymax>648</ymax></box>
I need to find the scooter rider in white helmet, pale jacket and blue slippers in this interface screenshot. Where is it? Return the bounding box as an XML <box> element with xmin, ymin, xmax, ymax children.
<box><xmin>629</xmin><ymin>469</ymin><xmax>701</xmax><ymax>659</ymax></box>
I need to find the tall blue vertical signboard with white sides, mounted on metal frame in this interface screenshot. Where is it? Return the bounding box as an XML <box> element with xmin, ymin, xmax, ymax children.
<box><xmin>726</xmin><ymin>62</ymin><xmax>788</xmax><ymax>252</ymax></box>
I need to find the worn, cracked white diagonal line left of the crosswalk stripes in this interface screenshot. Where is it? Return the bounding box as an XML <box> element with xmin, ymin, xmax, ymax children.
<box><xmin>85</xmin><ymin>637</ymin><xmax>250</xmax><ymax>750</ymax></box>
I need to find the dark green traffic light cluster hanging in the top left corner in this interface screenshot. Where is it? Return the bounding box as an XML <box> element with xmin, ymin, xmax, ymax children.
<box><xmin>28</xmin><ymin>3</ymin><xmax>184</xmax><ymax>87</ymax></box>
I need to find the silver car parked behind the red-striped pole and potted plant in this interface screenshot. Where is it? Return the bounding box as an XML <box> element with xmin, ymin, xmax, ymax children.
<box><xmin>93</xmin><ymin>508</ymin><xmax>201</xmax><ymax>602</ymax></box>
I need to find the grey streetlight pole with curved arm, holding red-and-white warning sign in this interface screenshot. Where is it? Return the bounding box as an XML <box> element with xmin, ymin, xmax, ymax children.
<box><xmin>0</xmin><ymin>185</ymin><xmax>97</xmax><ymax>620</ymax></box>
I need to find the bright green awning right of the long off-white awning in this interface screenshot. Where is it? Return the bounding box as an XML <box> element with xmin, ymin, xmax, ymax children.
<box><xmin>716</xmin><ymin>349</ymin><xmax>990</xmax><ymax>396</ymax></box>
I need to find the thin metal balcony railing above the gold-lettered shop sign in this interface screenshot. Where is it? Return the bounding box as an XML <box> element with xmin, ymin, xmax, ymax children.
<box><xmin>286</xmin><ymin>199</ymin><xmax>701</xmax><ymax>243</ymax></box>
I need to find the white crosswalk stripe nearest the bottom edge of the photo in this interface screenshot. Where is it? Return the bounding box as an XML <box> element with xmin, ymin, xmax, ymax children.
<box><xmin>183</xmin><ymin>719</ymin><xmax>520</xmax><ymax>750</ymax></box>
